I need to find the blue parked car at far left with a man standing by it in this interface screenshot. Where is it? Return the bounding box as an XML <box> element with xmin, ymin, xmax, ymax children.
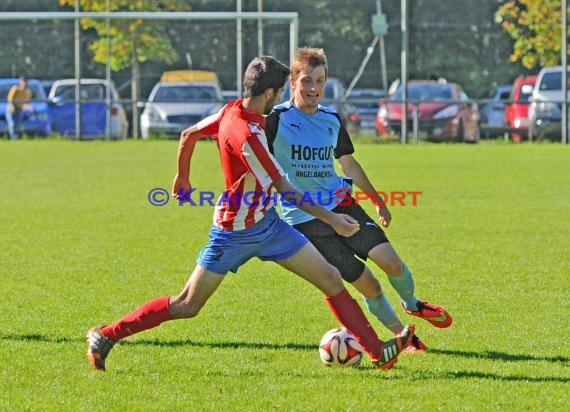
<box><xmin>0</xmin><ymin>78</ymin><xmax>52</xmax><ymax>136</ymax></box>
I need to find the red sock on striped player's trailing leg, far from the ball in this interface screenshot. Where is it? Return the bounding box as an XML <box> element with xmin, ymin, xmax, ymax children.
<box><xmin>101</xmin><ymin>296</ymin><xmax>172</xmax><ymax>342</ymax></box>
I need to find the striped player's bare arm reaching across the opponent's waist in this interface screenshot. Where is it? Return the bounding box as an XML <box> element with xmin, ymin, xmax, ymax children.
<box><xmin>273</xmin><ymin>177</ymin><xmax>360</xmax><ymax>237</ymax></box>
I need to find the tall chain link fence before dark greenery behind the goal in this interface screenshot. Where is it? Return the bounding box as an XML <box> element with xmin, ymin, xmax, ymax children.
<box><xmin>0</xmin><ymin>0</ymin><xmax>560</xmax><ymax>141</ymax></box>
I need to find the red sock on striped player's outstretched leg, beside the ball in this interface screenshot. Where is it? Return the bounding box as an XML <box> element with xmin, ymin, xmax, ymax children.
<box><xmin>326</xmin><ymin>289</ymin><xmax>382</xmax><ymax>361</ymax></box>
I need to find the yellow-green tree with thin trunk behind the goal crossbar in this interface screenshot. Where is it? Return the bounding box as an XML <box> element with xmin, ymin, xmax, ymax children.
<box><xmin>59</xmin><ymin>0</ymin><xmax>190</xmax><ymax>137</ymax></box>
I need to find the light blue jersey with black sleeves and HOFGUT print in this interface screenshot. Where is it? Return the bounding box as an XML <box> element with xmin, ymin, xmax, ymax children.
<box><xmin>265</xmin><ymin>101</ymin><xmax>354</xmax><ymax>225</ymax></box>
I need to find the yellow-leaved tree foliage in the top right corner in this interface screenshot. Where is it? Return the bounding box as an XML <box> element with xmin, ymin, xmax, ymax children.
<box><xmin>495</xmin><ymin>0</ymin><xmax>562</xmax><ymax>69</ymax></box>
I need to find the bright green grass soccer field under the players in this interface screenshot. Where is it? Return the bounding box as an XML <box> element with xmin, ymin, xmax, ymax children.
<box><xmin>0</xmin><ymin>140</ymin><xmax>570</xmax><ymax>411</ymax></box>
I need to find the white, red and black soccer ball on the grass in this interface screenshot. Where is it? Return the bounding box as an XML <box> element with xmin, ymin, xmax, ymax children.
<box><xmin>319</xmin><ymin>328</ymin><xmax>363</xmax><ymax>367</ymax></box>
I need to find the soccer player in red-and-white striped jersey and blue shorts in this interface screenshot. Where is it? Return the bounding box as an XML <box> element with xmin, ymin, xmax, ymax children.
<box><xmin>87</xmin><ymin>56</ymin><xmax>414</xmax><ymax>370</ymax></box>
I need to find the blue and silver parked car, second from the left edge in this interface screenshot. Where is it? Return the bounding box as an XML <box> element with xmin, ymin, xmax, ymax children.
<box><xmin>49</xmin><ymin>79</ymin><xmax>129</xmax><ymax>139</ymax></box>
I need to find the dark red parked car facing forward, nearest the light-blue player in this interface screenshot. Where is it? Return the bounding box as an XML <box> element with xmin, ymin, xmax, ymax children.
<box><xmin>376</xmin><ymin>80</ymin><xmax>480</xmax><ymax>142</ymax></box>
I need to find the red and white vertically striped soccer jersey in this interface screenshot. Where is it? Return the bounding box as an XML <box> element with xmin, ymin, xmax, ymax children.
<box><xmin>193</xmin><ymin>99</ymin><xmax>284</xmax><ymax>230</ymax></box>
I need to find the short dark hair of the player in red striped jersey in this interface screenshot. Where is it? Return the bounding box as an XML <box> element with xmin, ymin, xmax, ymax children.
<box><xmin>243</xmin><ymin>56</ymin><xmax>289</xmax><ymax>97</ymax></box>
